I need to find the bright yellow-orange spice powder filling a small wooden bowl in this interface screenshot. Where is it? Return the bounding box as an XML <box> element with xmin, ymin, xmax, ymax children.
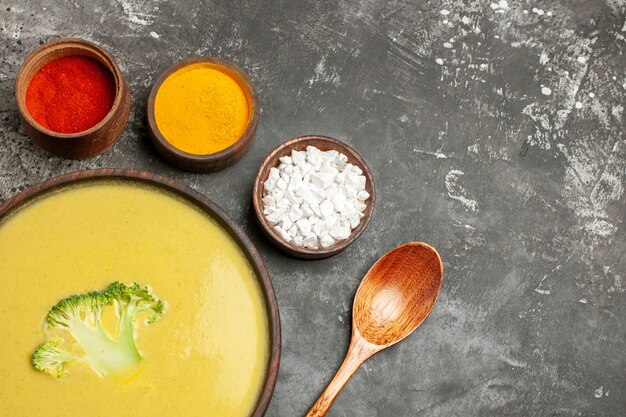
<box><xmin>154</xmin><ymin>63</ymin><xmax>250</xmax><ymax>155</ymax></box>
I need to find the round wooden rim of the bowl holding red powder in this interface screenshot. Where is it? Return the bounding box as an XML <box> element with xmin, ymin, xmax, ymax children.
<box><xmin>15</xmin><ymin>38</ymin><xmax>125</xmax><ymax>139</ymax></box>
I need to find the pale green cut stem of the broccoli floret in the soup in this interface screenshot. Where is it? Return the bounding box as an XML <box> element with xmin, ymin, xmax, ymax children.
<box><xmin>67</xmin><ymin>318</ymin><xmax>141</xmax><ymax>376</ymax></box>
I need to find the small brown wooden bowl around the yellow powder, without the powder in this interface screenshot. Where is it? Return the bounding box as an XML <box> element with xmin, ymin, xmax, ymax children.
<box><xmin>146</xmin><ymin>57</ymin><xmax>259</xmax><ymax>172</ymax></box>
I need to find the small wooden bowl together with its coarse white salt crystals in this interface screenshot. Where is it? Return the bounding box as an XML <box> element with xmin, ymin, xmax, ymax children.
<box><xmin>252</xmin><ymin>135</ymin><xmax>376</xmax><ymax>259</ymax></box>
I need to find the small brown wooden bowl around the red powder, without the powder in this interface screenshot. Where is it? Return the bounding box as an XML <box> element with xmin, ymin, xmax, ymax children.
<box><xmin>15</xmin><ymin>39</ymin><xmax>130</xmax><ymax>159</ymax></box>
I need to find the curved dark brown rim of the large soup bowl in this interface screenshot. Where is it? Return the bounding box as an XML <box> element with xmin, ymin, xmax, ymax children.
<box><xmin>0</xmin><ymin>168</ymin><xmax>281</xmax><ymax>417</ymax></box>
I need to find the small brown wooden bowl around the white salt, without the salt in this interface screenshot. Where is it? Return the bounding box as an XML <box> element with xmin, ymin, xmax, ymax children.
<box><xmin>252</xmin><ymin>135</ymin><xmax>376</xmax><ymax>259</ymax></box>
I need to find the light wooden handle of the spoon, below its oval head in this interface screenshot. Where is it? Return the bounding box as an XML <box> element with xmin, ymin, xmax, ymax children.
<box><xmin>305</xmin><ymin>333</ymin><xmax>377</xmax><ymax>417</ymax></box>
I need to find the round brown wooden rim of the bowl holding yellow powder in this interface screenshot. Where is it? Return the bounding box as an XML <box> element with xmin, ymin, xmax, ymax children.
<box><xmin>146</xmin><ymin>56</ymin><xmax>259</xmax><ymax>164</ymax></box>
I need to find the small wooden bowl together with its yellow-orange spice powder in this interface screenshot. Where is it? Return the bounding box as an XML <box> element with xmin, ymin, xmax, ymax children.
<box><xmin>147</xmin><ymin>57</ymin><xmax>259</xmax><ymax>172</ymax></box>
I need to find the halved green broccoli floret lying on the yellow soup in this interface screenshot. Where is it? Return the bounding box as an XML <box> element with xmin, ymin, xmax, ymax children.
<box><xmin>32</xmin><ymin>282</ymin><xmax>165</xmax><ymax>377</ymax></box>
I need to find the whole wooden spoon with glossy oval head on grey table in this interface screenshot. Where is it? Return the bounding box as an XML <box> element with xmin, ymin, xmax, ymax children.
<box><xmin>306</xmin><ymin>242</ymin><xmax>443</xmax><ymax>417</ymax></box>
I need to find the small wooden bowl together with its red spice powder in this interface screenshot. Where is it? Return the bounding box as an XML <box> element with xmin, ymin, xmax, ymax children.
<box><xmin>15</xmin><ymin>39</ymin><xmax>130</xmax><ymax>159</ymax></box>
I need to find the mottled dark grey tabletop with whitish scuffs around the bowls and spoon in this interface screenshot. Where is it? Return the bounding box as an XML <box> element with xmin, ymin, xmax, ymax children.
<box><xmin>0</xmin><ymin>0</ymin><xmax>626</xmax><ymax>417</ymax></box>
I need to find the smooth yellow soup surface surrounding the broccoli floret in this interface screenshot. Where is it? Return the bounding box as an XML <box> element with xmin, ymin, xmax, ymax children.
<box><xmin>0</xmin><ymin>180</ymin><xmax>269</xmax><ymax>417</ymax></box>
